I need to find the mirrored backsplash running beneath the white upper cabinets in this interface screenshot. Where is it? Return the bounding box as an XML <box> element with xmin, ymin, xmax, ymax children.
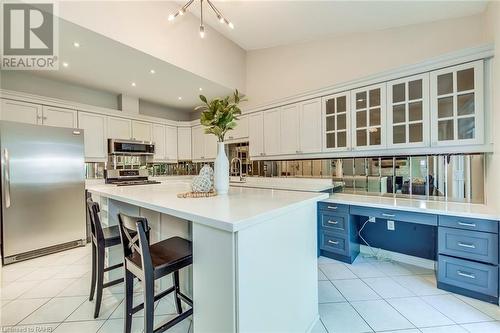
<box><xmin>86</xmin><ymin>152</ymin><xmax>485</xmax><ymax>203</ymax></box>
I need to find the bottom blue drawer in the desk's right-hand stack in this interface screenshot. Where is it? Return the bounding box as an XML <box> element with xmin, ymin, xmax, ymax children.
<box><xmin>438</xmin><ymin>255</ymin><xmax>498</xmax><ymax>297</ymax></box>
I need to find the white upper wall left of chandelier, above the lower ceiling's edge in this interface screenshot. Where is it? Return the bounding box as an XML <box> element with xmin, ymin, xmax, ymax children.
<box><xmin>59</xmin><ymin>1</ymin><xmax>246</xmax><ymax>91</ymax></box>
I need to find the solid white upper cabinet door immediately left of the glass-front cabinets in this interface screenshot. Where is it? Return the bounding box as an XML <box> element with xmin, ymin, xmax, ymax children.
<box><xmin>299</xmin><ymin>98</ymin><xmax>321</xmax><ymax>153</ymax></box>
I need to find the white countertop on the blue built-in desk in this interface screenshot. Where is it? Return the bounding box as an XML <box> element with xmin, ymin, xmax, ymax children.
<box><xmin>323</xmin><ymin>193</ymin><xmax>500</xmax><ymax>220</ymax></box>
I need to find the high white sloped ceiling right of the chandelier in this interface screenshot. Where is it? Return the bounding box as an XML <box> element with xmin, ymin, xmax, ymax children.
<box><xmin>185</xmin><ymin>0</ymin><xmax>487</xmax><ymax>50</ymax></box>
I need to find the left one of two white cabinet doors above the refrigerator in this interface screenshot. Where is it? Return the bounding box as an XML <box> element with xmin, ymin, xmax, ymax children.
<box><xmin>0</xmin><ymin>99</ymin><xmax>42</xmax><ymax>125</ymax></box>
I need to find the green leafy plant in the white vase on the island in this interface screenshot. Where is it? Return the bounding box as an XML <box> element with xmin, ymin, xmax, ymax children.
<box><xmin>195</xmin><ymin>89</ymin><xmax>246</xmax><ymax>142</ymax></box>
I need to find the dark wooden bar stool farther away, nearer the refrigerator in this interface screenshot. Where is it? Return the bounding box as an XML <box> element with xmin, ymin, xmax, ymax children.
<box><xmin>87</xmin><ymin>198</ymin><xmax>124</xmax><ymax>318</ymax></box>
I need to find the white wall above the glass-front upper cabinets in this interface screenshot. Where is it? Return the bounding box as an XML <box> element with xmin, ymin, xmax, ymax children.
<box><xmin>246</xmin><ymin>15</ymin><xmax>490</xmax><ymax>107</ymax></box>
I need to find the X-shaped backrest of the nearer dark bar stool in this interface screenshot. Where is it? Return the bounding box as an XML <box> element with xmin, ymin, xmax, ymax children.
<box><xmin>118</xmin><ymin>213</ymin><xmax>153</xmax><ymax>274</ymax></box>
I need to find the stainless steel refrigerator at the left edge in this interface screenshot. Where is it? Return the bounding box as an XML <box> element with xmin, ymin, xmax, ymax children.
<box><xmin>0</xmin><ymin>121</ymin><xmax>86</xmax><ymax>265</ymax></box>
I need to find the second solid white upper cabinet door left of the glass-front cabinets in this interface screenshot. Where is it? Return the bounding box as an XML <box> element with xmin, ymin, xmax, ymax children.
<box><xmin>280</xmin><ymin>104</ymin><xmax>300</xmax><ymax>155</ymax></box>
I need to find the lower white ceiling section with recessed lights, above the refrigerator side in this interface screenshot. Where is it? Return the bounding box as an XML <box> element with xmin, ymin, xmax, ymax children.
<box><xmin>23</xmin><ymin>19</ymin><xmax>231</xmax><ymax>111</ymax></box>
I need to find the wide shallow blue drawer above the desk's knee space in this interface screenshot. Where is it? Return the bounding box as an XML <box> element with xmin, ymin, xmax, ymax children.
<box><xmin>350</xmin><ymin>206</ymin><xmax>437</xmax><ymax>226</ymax></box>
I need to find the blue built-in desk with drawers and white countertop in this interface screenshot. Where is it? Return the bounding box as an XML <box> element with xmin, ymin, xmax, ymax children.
<box><xmin>318</xmin><ymin>194</ymin><xmax>500</xmax><ymax>304</ymax></box>
